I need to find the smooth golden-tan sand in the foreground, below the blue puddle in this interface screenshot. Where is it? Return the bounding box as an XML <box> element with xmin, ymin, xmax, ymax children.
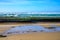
<box><xmin>0</xmin><ymin>32</ymin><xmax>60</xmax><ymax>40</ymax></box>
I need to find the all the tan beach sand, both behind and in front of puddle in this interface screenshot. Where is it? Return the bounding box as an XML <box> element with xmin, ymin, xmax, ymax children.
<box><xmin>0</xmin><ymin>22</ymin><xmax>60</xmax><ymax>40</ymax></box>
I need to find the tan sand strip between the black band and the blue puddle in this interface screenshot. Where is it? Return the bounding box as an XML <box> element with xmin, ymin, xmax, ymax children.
<box><xmin>0</xmin><ymin>22</ymin><xmax>60</xmax><ymax>32</ymax></box>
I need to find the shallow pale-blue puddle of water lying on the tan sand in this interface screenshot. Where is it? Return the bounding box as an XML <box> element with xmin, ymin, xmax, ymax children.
<box><xmin>4</xmin><ymin>25</ymin><xmax>60</xmax><ymax>35</ymax></box>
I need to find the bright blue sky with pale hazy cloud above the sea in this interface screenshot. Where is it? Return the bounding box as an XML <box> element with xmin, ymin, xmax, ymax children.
<box><xmin>0</xmin><ymin>0</ymin><xmax>60</xmax><ymax>12</ymax></box>
